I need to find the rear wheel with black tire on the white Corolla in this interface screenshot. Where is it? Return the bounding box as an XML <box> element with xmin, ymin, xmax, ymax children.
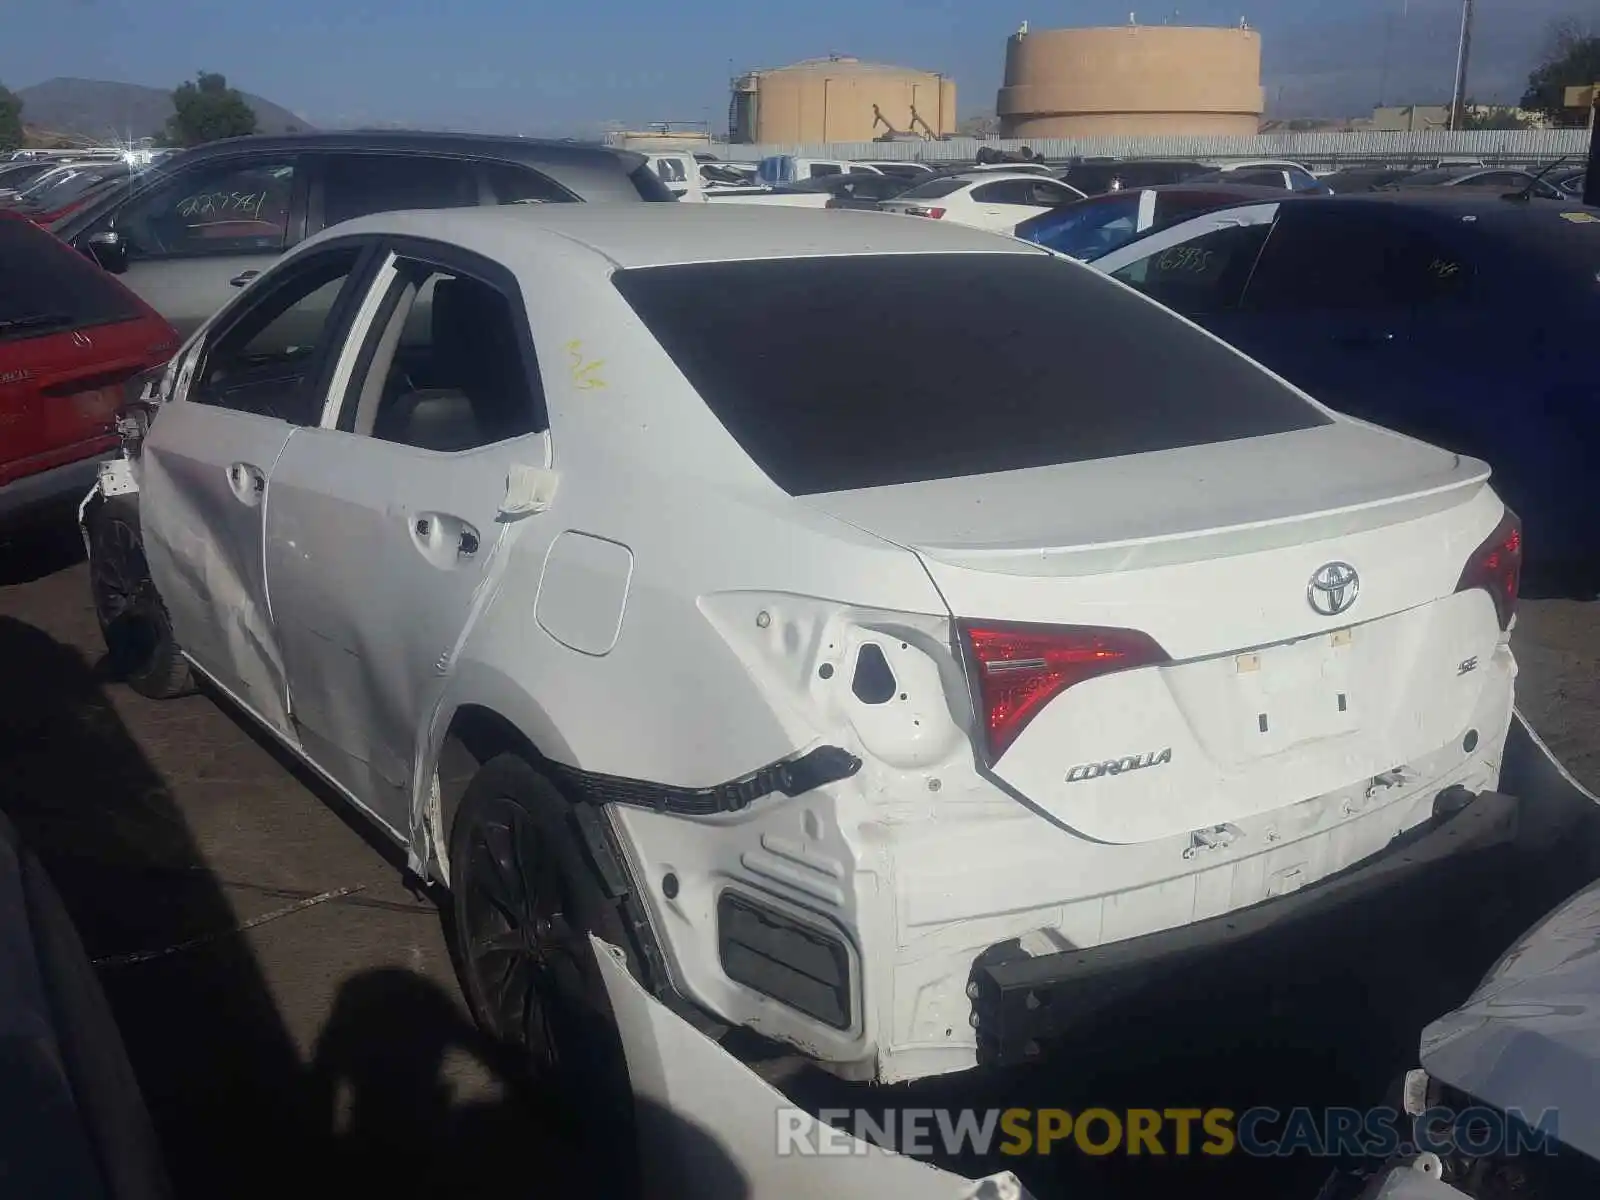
<box><xmin>450</xmin><ymin>754</ymin><xmax>637</xmax><ymax>1195</ymax></box>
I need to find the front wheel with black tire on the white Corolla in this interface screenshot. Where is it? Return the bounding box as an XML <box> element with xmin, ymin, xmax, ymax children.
<box><xmin>88</xmin><ymin>496</ymin><xmax>194</xmax><ymax>699</ymax></box>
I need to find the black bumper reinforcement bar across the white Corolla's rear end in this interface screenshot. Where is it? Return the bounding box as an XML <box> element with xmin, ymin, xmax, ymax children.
<box><xmin>970</xmin><ymin>789</ymin><xmax>1518</xmax><ymax>1066</ymax></box>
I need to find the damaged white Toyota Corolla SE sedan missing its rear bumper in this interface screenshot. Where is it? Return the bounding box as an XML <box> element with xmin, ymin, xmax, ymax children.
<box><xmin>82</xmin><ymin>205</ymin><xmax>1520</xmax><ymax>1107</ymax></box>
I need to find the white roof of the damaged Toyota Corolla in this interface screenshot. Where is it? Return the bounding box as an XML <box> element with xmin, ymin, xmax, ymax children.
<box><xmin>318</xmin><ymin>205</ymin><xmax>1045</xmax><ymax>267</ymax></box>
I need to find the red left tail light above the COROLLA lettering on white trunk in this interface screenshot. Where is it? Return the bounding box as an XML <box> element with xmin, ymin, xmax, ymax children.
<box><xmin>958</xmin><ymin>621</ymin><xmax>1170</xmax><ymax>766</ymax></box>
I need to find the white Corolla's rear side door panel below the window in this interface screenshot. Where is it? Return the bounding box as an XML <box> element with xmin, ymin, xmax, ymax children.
<box><xmin>267</xmin><ymin>429</ymin><xmax>549</xmax><ymax>835</ymax></box>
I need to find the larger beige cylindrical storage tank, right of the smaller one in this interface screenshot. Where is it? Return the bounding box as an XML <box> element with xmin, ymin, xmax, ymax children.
<box><xmin>995</xmin><ymin>26</ymin><xmax>1264</xmax><ymax>138</ymax></box>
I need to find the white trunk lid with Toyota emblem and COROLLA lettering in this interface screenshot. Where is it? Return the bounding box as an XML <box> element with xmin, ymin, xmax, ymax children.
<box><xmin>810</xmin><ymin>421</ymin><xmax>1502</xmax><ymax>843</ymax></box>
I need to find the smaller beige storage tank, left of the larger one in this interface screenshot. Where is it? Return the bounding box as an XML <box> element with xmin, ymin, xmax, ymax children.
<box><xmin>728</xmin><ymin>54</ymin><xmax>955</xmax><ymax>146</ymax></box>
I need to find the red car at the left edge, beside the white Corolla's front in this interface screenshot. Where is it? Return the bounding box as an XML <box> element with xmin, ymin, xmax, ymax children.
<box><xmin>0</xmin><ymin>211</ymin><xmax>178</xmax><ymax>526</ymax></box>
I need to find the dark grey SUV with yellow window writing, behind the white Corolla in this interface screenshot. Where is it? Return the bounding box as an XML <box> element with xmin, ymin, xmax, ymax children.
<box><xmin>53</xmin><ymin>131</ymin><xmax>675</xmax><ymax>336</ymax></box>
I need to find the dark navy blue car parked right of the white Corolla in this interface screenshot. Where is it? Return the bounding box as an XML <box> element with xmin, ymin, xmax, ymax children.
<box><xmin>1093</xmin><ymin>187</ymin><xmax>1600</xmax><ymax>598</ymax></box>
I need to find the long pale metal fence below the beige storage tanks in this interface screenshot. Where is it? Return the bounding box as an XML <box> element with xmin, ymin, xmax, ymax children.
<box><xmin>715</xmin><ymin>130</ymin><xmax>1589</xmax><ymax>166</ymax></box>
